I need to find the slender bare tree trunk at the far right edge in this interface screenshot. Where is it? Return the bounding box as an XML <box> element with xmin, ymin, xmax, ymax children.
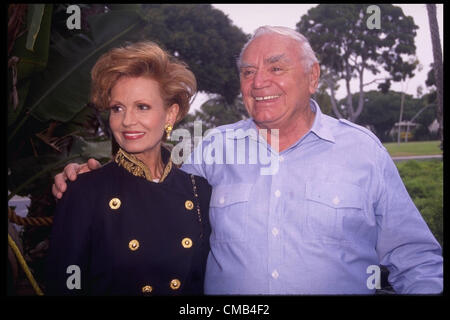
<box><xmin>427</xmin><ymin>4</ymin><xmax>444</xmax><ymax>148</ymax></box>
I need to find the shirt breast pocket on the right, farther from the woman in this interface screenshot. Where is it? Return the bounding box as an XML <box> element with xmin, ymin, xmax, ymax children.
<box><xmin>305</xmin><ymin>181</ymin><xmax>365</xmax><ymax>243</ymax></box>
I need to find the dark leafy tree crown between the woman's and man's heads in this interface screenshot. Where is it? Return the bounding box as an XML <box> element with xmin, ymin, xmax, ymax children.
<box><xmin>136</xmin><ymin>4</ymin><xmax>247</xmax><ymax>104</ymax></box>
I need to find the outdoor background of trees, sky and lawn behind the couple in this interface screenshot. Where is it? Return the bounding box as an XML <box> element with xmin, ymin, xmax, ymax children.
<box><xmin>6</xmin><ymin>4</ymin><xmax>443</xmax><ymax>295</ymax></box>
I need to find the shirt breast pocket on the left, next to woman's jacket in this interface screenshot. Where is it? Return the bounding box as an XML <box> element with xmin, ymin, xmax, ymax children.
<box><xmin>210</xmin><ymin>184</ymin><xmax>252</xmax><ymax>242</ymax></box>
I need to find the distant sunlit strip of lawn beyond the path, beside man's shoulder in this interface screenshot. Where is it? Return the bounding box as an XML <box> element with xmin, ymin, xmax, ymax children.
<box><xmin>383</xmin><ymin>140</ymin><xmax>442</xmax><ymax>157</ymax></box>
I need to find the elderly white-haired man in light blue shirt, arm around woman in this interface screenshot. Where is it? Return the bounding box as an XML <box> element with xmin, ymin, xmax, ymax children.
<box><xmin>53</xmin><ymin>26</ymin><xmax>443</xmax><ymax>294</ymax></box>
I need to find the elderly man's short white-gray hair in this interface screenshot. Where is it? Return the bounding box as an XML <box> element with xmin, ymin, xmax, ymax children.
<box><xmin>237</xmin><ymin>26</ymin><xmax>318</xmax><ymax>71</ymax></box>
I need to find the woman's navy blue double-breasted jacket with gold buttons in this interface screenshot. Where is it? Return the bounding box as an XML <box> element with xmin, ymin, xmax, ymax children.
<box><xmin>46</xmin><ymin>157</ymin><xmax>211</xmax><ymax>295</ymax></box>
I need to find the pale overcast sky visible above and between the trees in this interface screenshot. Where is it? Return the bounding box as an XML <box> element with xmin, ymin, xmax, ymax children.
<box><xmin>191</xmin><ymin>4</ymin><xmax>444</xmax><ymax>112</ymax></box>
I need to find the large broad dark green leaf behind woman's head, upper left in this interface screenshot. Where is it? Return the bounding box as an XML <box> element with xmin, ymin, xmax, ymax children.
<box><xmin>25</xmin><ymin>10</ymin><xmax>141</xmax><ymax>122</ymax></box>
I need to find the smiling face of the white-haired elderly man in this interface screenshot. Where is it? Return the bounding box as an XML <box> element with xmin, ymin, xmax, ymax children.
<box><xmin>240</xmin><ymin>33</ymin><xmax>318</xmax><ymax>129</ymax></box>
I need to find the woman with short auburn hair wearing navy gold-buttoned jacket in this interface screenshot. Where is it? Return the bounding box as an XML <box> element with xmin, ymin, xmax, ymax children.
<box><xmin>46</xmin><ymin>42</ymin><xmax>211</xmax><ymax>295</ymax></box>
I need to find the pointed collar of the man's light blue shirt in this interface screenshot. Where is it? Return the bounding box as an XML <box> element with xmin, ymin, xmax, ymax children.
<box><xmin>228</xmin><ymin>99</ymin><xmax>335</xmax><ymax>143</ymax></box>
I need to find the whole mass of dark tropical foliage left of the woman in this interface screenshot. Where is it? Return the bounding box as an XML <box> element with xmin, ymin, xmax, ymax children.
<box><xmin>8</xmin><ymin>5</ymin><xmax>146</xmax><ymax>197</ymax></box>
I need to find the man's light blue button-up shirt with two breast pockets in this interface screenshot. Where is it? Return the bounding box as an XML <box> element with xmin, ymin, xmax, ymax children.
<box><xmin>182</xmin><ymin>100</ymin><xmax>443</xmax><ymax>294</ymax></box>
